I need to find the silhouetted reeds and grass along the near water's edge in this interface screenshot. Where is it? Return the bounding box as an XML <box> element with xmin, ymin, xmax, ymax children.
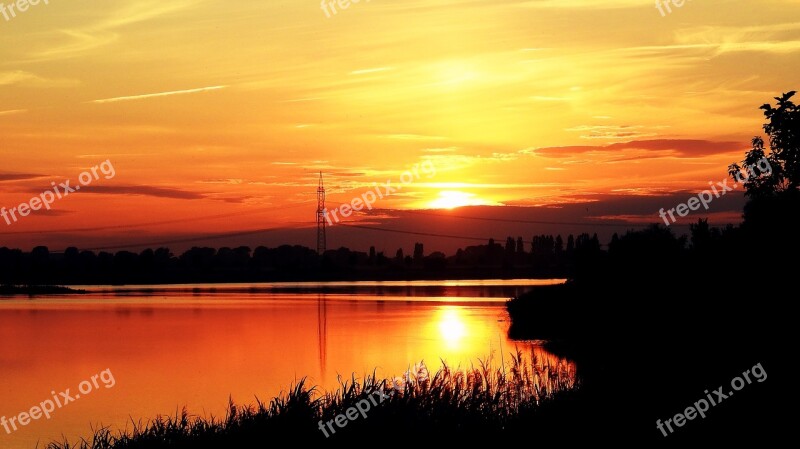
<box><xmin>47</xmin><ymin>353</ymin><xmax>580</xmax><ymax>449</ymax></box>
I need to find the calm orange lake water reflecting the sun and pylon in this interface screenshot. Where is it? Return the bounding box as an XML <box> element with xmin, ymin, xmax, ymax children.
<box><xmin>0</xmin><ymin>280</ymin><xmax>572</xmax><ymax>449</ymax></box>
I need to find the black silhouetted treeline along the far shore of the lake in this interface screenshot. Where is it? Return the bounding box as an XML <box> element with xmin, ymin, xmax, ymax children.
<box><xmin>0</xmin><ymin>234</ymin><xmax>600</xmax><ymax>285</ymax></box>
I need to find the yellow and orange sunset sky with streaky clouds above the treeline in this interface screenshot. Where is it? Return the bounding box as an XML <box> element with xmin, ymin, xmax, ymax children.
<box><xmin>0</xmin><ymin>0</ymin><xmax>800</xmax><ymax>254</ymax></box>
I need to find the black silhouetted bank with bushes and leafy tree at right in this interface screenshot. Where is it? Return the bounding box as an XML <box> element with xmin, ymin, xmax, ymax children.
<box><xmin>508</xmin><ymin>93</ymin><xmax>800</xmax><ymax>440</ymax></box>
